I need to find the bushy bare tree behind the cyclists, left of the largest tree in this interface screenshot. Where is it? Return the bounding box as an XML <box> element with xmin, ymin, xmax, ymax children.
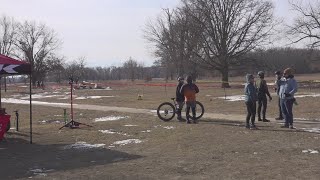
<box><xmin>145</xmin><ymin>7</ymin><xmax>198</xmax><ymax>79</ymax></box>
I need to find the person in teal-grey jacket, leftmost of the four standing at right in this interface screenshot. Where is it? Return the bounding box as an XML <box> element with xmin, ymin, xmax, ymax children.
<box><xmin>244</xmin><ymin>74</ymin><xmax>257</xmax><ymax>129</ymax></box>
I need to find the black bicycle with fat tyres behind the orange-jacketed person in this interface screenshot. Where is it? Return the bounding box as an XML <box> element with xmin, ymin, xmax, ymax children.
<box><xmin>157</xmin><ymin>98</ymin><xmax>204</xmax><ymax>121</ymax></box>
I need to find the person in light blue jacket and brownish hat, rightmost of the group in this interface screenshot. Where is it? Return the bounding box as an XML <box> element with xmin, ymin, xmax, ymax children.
<box><xmin>277</xmin><ymin>68</ymin><xmax>298</xmax><ymax>129</ymax></box>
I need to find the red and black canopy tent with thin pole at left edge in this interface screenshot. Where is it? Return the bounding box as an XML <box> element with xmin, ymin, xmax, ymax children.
<box><xmin>0</xmin><ymin>54</ymin><xmax>32</xmax><ymax>144</ymax></box>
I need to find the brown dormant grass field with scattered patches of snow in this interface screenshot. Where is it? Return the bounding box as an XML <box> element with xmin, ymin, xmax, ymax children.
<box><xmin>0</xmin><ymin>74</ymin><xmax>320</xmax><ymax>179</ymax></box>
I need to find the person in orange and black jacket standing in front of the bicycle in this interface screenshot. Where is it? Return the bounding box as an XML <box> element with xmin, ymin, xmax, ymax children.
<box><xmin>180</xmin><ymin>75</ymin><xmax>199</xmax><ymax>124</ymax></box>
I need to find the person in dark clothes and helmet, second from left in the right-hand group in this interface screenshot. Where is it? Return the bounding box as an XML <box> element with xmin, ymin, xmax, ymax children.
<box><xmin>256</xmin><ymin>71</ymin><xmax>272</xmax><ymax>122</ymax></box>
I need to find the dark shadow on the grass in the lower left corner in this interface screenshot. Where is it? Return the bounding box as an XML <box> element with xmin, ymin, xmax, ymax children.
<box><xmin>0</xmin><ymin>138</ymin><xmax>142</xmax><ymax>179</ymax></box>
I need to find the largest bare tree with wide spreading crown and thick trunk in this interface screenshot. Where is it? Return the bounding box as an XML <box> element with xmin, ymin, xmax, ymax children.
<box><xmin>184</xmin><ymin>0</ymin><xmax>275</xmax><ymax>87</ymax></box>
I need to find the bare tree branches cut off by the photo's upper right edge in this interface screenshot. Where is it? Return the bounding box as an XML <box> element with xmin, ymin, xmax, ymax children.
<box><xmin>288</xmin><ymin>0</ymin><xmax>320</xmax><ymax>48</ymax></box>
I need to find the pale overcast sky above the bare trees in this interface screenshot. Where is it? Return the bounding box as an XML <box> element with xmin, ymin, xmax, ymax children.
<box><xmin>0</xmin><ymin>0</ymin><xmax>298</xmax><ymax>66</ymax></box>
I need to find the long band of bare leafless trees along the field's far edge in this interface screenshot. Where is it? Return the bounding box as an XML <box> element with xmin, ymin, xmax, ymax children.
<box><xmin>0</xmin><ymin>0</ymin><xmax>320</xmax><ymax>87</ymax></box>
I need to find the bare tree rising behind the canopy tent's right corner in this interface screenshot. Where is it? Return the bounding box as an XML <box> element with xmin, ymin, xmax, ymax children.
<box><xmin>15</xmin><ymin>21</ymin><xmax>60</xmax><ymax>85</ymax></box>
